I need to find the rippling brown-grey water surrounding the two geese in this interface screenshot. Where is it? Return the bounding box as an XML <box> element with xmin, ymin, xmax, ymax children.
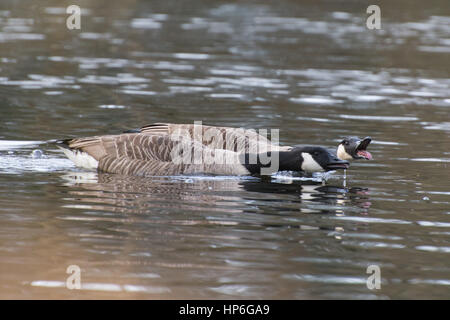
<box><xmin>0</xmin><ymin>0</ymin><xmax>450</xmax><ymax>299</ymax></box>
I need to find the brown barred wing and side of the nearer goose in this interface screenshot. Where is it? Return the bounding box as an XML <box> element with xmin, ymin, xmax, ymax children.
<box><xmin>66</xmin><ymin>133</ymin><xmax>248</xmax><ymax>176</ymax></box>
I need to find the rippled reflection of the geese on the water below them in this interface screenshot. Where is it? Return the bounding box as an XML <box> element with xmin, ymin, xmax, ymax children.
<box><xmin>58</xmin><ymin>172</ymin><xmax>370</xmax><ymax>215</ymax></box>
